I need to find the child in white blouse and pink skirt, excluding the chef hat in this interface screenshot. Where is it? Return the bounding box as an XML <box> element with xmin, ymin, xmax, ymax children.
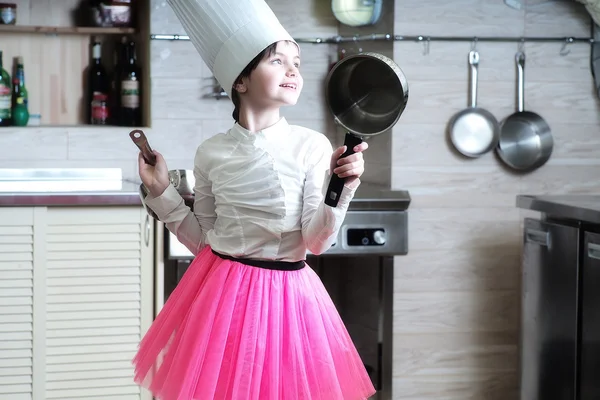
<box><xmin>134</xmin><ymin>0</ymin><xmax>375</xmax><ymax>400</ymax></box>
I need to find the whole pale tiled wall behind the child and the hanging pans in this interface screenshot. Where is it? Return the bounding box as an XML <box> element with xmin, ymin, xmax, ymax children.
<box><xmin>0</xmin><ymin>0</ymin><xmax>600</xmax><ymax>400</ymax></box>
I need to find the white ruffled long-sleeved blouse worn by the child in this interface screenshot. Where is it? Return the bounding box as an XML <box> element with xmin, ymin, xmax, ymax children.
<box><xmin>146</xmin><ymin>118</ymin><xmax>356</xmax><ymax>261</ymax></box>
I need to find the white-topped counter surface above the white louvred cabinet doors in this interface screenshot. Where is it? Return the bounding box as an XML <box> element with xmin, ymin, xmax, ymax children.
<box><xmin>0</xmin><ymin>168</ymin><xmax>142</xmax><ymax>207</ymax></box>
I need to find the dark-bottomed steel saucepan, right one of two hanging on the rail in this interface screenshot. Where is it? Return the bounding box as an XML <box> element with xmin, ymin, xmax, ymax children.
<box><xmin>496</xmin><ymin>51</ymin><xmax>554</xmax><ymax>171</ymax></box>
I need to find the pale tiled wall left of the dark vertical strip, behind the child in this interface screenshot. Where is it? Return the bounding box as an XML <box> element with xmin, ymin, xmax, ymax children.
<box><xmin>0</xmin><ymin>0</ymin><xmax>337</xmax><ymax>180</ymax></box>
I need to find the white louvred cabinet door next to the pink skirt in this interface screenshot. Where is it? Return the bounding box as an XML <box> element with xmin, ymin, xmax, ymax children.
<box><xmin>45</xmin><ymin>207</ymin><xmax>154</xmax><ymax>400</ymax></box>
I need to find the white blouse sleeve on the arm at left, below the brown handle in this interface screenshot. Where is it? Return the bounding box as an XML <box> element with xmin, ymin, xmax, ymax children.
<box><xmin>146</xmin><ymin>148</ymin><xmax>217</xmax><ymax>255</ymax></box>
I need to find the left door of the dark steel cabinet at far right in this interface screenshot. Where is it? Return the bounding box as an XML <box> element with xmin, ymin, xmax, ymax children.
<box><xmin>521</xmin><ymin>219</ymin><xmax>579</xmax><ymax>400</ymax></box>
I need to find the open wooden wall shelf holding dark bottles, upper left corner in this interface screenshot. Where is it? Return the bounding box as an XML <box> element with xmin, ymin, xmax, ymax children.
<box><xmin>0</xmin><ymin>0</ymin><xmax>151</xmax><ymax>126</ymax></box>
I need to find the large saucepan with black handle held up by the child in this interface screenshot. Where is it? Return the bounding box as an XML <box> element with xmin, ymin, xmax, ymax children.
<box><xmin>325</xmin><ymin>52</ymin><xmax>408</xmax><ymax>207</ymax></box>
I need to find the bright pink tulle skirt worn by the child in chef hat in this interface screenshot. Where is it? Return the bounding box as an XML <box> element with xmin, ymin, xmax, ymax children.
<box><xmin>133</xmin><ymin>247</ymin><xmax>375</xmax><ymax>400</ymax></box>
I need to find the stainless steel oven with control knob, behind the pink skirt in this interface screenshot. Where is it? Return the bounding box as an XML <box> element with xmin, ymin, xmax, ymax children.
<box><xmin>164</xmin><ymin>184</ymin><xmax>410</xmax><ymax>400</ymax></box>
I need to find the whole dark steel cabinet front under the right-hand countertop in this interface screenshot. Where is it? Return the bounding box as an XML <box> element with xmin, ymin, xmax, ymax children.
<box><xmin>520</xmin><ymin>217</ymin><xmax>600</xmax><ymax>400</ymax></box>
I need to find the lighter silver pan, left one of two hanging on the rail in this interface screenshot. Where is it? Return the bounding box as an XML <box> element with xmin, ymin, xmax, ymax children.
<box><xmin>448</xmin><ymin>50</ymin><xmax>500</xmax><ymax>158</ymax></box>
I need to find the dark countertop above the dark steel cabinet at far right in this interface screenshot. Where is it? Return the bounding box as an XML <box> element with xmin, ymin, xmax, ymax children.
<box><xmin>517</xmin><ymin>194</ymin><xmax>600</xmax><ymax>224</ymax></box>
